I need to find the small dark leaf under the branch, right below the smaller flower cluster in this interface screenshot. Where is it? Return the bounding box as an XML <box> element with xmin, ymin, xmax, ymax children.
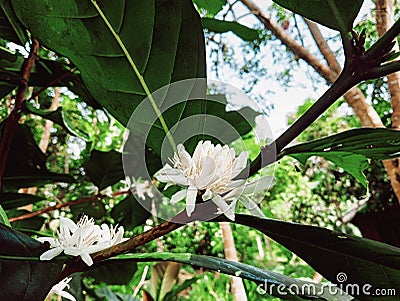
<box><xmin>83</xmin><ymin>260</ymin><xmax>137</xmax><ymax>285</ymax></box>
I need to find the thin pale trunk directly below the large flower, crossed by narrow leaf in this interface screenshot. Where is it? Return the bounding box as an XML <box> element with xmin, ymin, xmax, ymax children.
<box><xmin>220</xmin><ymin>222</ymin><xmax>247</xmax><ymax>301</ymax></box>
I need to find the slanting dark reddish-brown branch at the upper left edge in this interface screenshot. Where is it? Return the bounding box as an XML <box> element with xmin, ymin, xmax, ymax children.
<box><xmin>0</xmin><ymin>39</ymin><xmax>39</xmax><ymax>188</ymax></box>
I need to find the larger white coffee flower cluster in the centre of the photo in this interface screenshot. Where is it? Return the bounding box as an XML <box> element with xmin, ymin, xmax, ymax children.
<box><xmin>155</xmin><ymin>141</ymin><xmax>275</xmax><ymax>220</ymax></box>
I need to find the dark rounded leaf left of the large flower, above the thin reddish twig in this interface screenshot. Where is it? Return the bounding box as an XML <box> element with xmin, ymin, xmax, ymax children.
<box><xmin>83</xmin><ymin>150</ymin><xmax>125</xmax><ymax>190</ymax></box>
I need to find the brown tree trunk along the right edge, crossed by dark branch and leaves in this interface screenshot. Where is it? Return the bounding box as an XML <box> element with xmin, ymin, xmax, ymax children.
<box><xmin>375</xmin><ymin>0</ymin><xmax>400</xmax><ymax>202</ymax></box>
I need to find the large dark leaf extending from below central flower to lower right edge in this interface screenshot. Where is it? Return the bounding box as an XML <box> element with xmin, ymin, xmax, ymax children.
<box><xmin>227</xmin><ymin>214</ymin><xmax>400</xmax><ymax>300</ymax></box>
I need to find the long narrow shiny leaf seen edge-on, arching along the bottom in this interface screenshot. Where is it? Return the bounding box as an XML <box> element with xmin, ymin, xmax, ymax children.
<box><xmin>114</xmin><ymin>252</ymin><xmax>352</xmax><ymax>301</ymax></box>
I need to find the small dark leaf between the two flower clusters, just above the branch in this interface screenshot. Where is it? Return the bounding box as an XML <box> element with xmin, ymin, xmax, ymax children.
<box><xmin>111</xmin><ymin>195</ymin><xmax>150</xmax><ymax>230</ymax></box>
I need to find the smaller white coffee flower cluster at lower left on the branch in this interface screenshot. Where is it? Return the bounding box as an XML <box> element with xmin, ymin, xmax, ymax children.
<box><xmin>38</xmin><ymin>215</ymin><xmax>124</xmax><ymax>266</ymax></box>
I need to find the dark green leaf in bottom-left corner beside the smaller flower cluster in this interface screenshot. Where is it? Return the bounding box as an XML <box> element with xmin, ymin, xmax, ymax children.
<box><xmin>0</xmin><ymin>224</ymin><xmax>63</xmax><ymax>301</ymax></box>
